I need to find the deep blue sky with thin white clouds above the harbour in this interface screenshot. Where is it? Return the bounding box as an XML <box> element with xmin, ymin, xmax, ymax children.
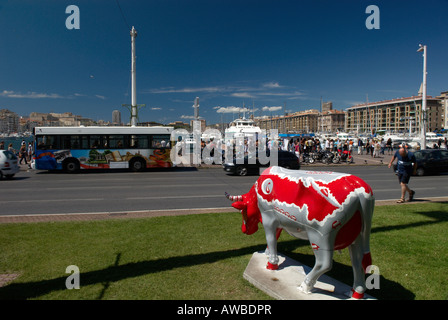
<box><xmin>0</xmin><ymin>0</ymin><xmax>448</xmax><ymax>124</ymax></box>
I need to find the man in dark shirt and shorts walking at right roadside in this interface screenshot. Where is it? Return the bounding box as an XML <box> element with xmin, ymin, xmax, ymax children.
<box><xmin>388</xmin><ymin>146</ymin><xmax>417</xmax><ymax>203</ymax></box>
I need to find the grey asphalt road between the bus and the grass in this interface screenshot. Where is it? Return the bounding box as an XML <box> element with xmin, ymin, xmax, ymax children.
<box><xmin>0</xmin><ymin>165</ymin><xmax>448</xmax><ymax>215</ymax></box>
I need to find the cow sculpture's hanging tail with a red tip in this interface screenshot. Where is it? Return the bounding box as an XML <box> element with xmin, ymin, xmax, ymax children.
<box><xmin>359</xmin><ymin>190</ymin><xmax>375</xmax><ymax>272</ymax></box>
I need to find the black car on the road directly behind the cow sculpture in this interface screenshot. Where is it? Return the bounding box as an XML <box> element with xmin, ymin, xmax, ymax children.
<box><xmin>223</xmin><ymin>151</ymin><xmax>300</xmax><ymax>176</ymax></box>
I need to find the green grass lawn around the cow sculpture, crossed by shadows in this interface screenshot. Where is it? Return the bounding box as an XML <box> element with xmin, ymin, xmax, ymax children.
<box><xmin>0</xmin><ymin>203</ymin><xmax>448</xmax><ymax>300</ymax></box>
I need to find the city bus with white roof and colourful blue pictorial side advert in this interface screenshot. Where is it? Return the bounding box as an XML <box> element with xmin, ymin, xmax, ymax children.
<box><xmin>33</xmin><ymin>126</ymin><xmax>173</xmax><ymax>173</ymax></box>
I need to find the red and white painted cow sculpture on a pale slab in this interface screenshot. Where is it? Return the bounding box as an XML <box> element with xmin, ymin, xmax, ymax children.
<box><xmin>226</xmin><ymin>167</ymin><xmax>375</xmax><ymax>299</ymax></box>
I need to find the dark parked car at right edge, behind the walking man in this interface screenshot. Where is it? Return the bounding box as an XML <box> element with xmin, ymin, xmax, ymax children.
<box><xmin>394</xmin><ymin>149</ymin><xmax>448</xmax><ymax>176</ymax></box>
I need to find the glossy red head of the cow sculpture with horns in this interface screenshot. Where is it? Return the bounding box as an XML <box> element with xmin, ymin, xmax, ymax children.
<box><xmin>226</xmin><ymin>187</ymin><xmax>262</xmax><ymax>235</ymax></box>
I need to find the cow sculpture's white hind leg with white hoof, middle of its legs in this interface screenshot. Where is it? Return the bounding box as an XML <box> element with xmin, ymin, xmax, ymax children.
<box><xmin>299</xmin><ymin>233</ymin><xmax>334</xmax><ymax>293</ymax></box>
